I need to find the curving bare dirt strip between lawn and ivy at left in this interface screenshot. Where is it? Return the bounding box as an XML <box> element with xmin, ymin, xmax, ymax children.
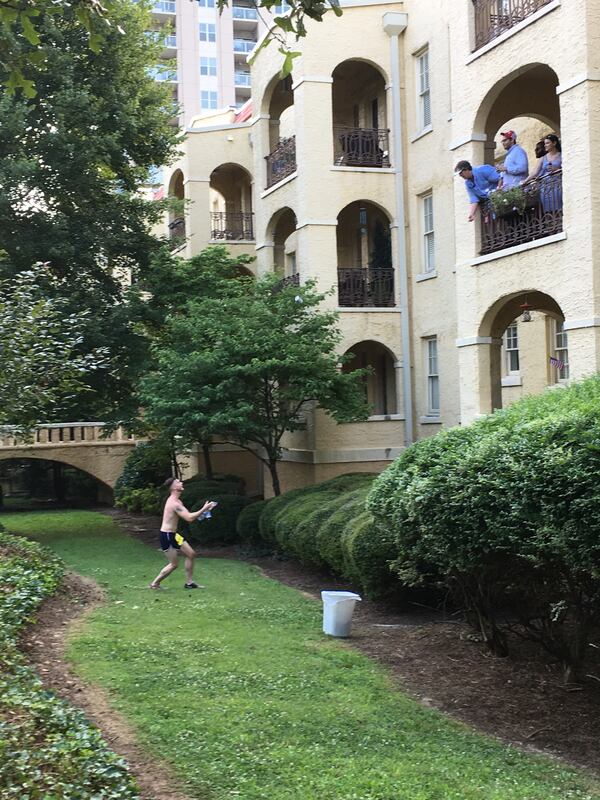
<box><xmin>21</xmin><ymin>573</ymin><xmax>195</xmax><ymax>800</ymax></box>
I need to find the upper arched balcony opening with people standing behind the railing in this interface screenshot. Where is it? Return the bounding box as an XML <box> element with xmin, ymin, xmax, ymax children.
<box><xmin>478</xmin><ymin>64</ymin><xmax>563</xmax><ymax>255</ymax></box>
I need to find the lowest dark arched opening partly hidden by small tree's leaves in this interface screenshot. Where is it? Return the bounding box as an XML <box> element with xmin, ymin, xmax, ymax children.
<box><xmin>342</xmin><ymin>341</ymin><xmax>398</xmax><ymax>417</ymax></box>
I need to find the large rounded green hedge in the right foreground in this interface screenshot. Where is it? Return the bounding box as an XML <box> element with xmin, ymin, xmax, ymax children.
<box><xmin>367</xmin><ymin>376</ymin><xmax>600</xmax><ymax>677</ymax></box>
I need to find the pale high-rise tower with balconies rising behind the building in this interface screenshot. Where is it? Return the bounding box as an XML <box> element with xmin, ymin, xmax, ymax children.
<box><xmin>152</xmin><ymin>0</ymin><xmax>289</xmax><ymax>128</ymax></box>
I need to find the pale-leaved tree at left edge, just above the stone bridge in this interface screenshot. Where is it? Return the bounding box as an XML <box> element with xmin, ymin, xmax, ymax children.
<box><xmin>0</xmin><ymin>264</ymin><xmax>108</xmax><ymax>433</ymax></box>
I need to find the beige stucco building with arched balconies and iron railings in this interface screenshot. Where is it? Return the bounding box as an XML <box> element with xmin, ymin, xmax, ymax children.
<box><xmin>162</xmin><ymin>0</ymin><xmax>600</xmax><ymax>488</ymax></box>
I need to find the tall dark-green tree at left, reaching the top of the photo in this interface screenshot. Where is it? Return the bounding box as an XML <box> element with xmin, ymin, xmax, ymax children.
<box><xmin>0</xmin><ymin>0</ymin><xmax>179</xmax><ymax>419</ymax></box>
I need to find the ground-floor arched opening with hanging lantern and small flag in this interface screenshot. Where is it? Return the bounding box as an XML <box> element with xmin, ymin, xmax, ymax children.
<box><xmin>480</xmin><ymin>291</ymin><xmax>569</xmax><ymax>409</ymax></box>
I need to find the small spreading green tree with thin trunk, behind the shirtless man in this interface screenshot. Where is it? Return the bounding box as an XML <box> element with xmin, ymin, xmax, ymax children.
<box><xmin>141</xmin><ymin>264</ymin><xmax>368</xmax><ymax>495</ymax></box>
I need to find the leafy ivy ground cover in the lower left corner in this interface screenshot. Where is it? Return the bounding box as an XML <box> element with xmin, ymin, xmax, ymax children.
<box><xmin>0</xmin><ymin>525</ymin><xmax>139</xmax><ymax>800</ymax></box>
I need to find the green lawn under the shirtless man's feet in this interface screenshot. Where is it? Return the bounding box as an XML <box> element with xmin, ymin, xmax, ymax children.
<box><xmin>1</xmin><ymin>511</ymin><xmax>600</xmax><ymax>800</ymax></box>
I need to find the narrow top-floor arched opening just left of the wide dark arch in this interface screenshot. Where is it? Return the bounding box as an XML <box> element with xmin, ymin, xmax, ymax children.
<box><xmin>265</xmin><ymin>75</ymin><xmax>296</xmax><ymax>189</ymax></box>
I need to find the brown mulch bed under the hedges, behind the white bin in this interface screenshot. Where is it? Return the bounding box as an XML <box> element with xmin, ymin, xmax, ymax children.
<box><xmin>106</xmin><ymin>509</ymin><xmax>600</xmax><ymax>773</ymax></box>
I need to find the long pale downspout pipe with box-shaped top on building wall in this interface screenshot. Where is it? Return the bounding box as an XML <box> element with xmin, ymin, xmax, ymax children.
<box><xmin>383</xmin><ymin>11</ymin><xmax>414</xmax><ymax>447</ymax></box>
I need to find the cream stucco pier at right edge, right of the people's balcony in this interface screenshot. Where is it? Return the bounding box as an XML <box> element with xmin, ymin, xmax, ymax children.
<box><xmin>556</xmin><ymin>76</ymin><xmax>600</xmax><ymax>380</ymax></box>
